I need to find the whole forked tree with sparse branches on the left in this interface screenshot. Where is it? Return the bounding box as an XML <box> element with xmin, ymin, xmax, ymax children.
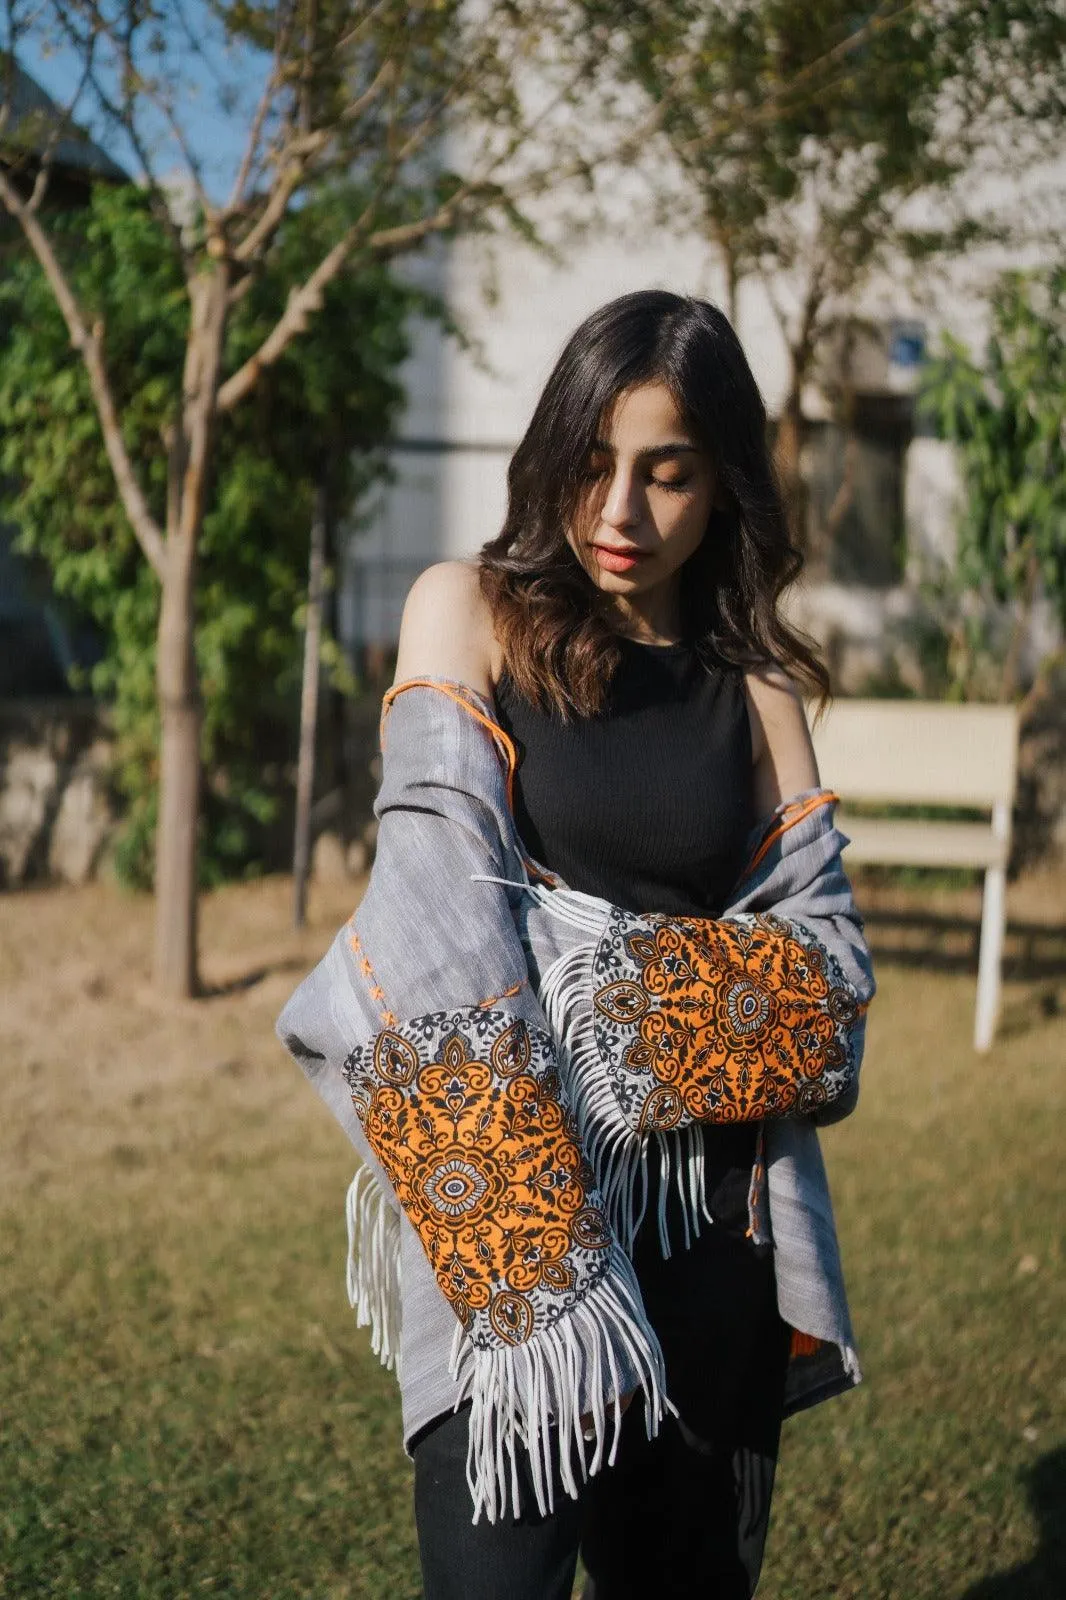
<box><xmin>0</xmin><ymin>0</ymin><xmax>611</xmax><ymax>995</ymax></box>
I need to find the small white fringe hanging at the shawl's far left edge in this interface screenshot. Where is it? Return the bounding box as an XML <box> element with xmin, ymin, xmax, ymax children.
<box><xmin>344</xmin><ymin>1166</ymin><xmax>400</xmax><ymax>1374</ymax></box>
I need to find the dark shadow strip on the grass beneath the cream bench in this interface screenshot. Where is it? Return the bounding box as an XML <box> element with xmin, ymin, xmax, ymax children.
<box><xmin>861</xmin><ymin>907</ymin><xmax>1066</xmax><ymax>982</ymax></box>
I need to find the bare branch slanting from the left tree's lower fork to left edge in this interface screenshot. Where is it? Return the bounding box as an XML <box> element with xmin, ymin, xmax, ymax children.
<box><xmin>0</xmin><ymin>168</ymin><xmax>166</xmax><ymax>581</ymax></box>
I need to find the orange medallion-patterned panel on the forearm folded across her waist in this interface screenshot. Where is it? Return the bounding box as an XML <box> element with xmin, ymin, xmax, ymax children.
<box><xmin>592</xmin><ymin>907</ymin><xmax>858</xmax><ymax>1133</ymax></box>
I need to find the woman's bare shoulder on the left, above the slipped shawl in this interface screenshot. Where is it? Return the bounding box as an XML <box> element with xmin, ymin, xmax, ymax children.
<box><xmin>395</xmin><ymin>562</ymin><xmax>496</xmax><ymax>694</ymax></box>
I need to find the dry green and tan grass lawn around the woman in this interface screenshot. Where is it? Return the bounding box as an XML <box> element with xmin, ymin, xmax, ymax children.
<box><xmin>0</xmin><ymin>880</ymin><xmax>1066</xmax><ymax>1600</ymax></box>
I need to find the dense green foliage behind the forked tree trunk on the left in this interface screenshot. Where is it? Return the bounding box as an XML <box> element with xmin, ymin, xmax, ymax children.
<box><xmin>0</xmin><ymin>187</ymin><xmax>423</xmax><ymax>883</ymax></box>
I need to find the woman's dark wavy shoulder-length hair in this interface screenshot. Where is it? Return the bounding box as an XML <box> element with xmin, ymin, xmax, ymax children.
<box><xmin>479</xmin><ymin>290</ymin><xmax>829</xmax><ymax>718</ymax></box>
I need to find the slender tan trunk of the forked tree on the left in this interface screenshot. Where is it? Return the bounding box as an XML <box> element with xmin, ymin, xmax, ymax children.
<box><xmin>155</xmin><ymin>266</ymin><xmax>229</xmax><ymax>998</ymax></box>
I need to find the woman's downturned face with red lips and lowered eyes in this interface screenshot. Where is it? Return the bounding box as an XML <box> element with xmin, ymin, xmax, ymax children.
<box><xmin>567</xmin><ymin>384</ymin><xmax>714</xmax><ymax>632</ymax></box>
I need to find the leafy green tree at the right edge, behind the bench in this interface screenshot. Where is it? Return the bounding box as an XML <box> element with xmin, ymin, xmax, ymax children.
<box><xmin>922</xmin><ymin>266</ymin><xmax>1066</xmax><ymax>701</ymax></box>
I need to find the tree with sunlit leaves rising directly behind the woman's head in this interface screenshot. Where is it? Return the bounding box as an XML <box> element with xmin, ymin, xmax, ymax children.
<box><xmin>587</xmin><ymin>0</ymin><xmax>1066</xmax><ymax>537</ymax></box>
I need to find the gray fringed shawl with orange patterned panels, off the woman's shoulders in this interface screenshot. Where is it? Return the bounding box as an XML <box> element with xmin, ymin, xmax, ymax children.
<box><xmin>279</xmin><ymin>678</ymin><xmax>874</xmax><ymax>1520</ymax></box>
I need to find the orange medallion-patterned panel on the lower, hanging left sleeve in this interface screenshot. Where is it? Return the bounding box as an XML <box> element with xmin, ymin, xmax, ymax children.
<box><xmin>344</xmin><ymin>1006</ymin><xmax>611</xmax><ymax>1349</ymax></box>
